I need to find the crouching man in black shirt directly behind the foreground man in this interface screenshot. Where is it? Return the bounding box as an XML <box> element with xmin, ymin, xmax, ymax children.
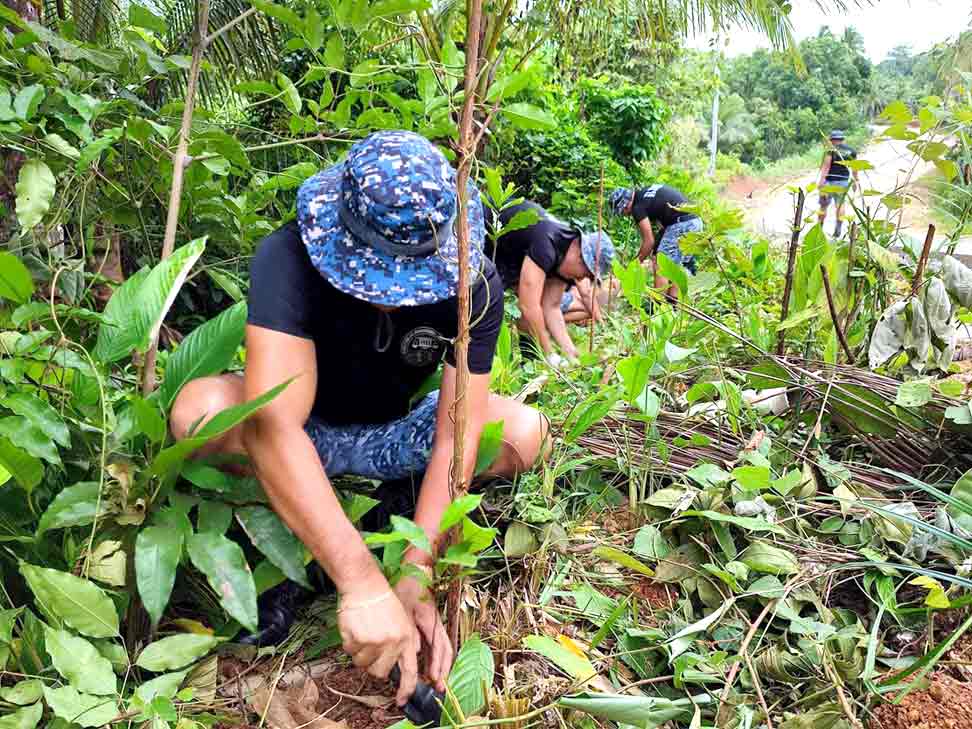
<box><xmin>489</xmin><ymin>200</ymin><xmax>614</xmax><ymax>367</ymax></box>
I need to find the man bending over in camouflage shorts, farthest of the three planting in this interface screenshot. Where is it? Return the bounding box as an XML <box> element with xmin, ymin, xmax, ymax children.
<box><xmin>611</xmin><ymin>185</ymin><xmax>704</xmax><ymax>301</ymax></box>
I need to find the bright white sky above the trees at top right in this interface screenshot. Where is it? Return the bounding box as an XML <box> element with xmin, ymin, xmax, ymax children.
<box><xmin>693</xmin><ymin>0</ymin><xmax>972</xmax><ymax>63</ymax></box>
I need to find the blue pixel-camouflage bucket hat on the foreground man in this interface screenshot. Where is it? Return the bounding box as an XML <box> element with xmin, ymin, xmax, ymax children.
<box><xmin>297</xmin><ymin>131</ymin><xmax>485</xmax><ymax>306</ymax></box>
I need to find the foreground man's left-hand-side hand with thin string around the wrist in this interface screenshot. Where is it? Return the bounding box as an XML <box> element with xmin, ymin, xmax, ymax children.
<box><xmin>338</xmin><ymin>578</ymin><xmax>419</xmax><ymax>706</ymax></box>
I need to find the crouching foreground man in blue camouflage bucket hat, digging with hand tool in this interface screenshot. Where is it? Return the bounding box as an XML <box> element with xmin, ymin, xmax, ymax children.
<box><xmin>171</xmin><ymin>131</ymin><xmax>547</xmax><ymax>705</ymax></box>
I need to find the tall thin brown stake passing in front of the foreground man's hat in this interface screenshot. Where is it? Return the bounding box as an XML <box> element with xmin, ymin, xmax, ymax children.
<box><xmin>448</xmin><ymin>0</ymin><xmax>483</xmax><ymax>650</ymax></box>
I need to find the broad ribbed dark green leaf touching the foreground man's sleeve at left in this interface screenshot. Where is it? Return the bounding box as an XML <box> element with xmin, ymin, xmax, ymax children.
<box><xmin>159</xmin><ymin>301</ymin><xmax>246</xmax><ymax>410</ymax></box>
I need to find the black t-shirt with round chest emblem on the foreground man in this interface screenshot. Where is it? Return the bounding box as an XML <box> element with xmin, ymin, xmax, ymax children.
<box><xmin>247</xmin><ymin>222</ymin><xmax>503</xmax><ymax>425</ymax></box>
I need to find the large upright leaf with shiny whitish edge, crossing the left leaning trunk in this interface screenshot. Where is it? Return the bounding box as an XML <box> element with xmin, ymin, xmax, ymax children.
<box><xmin>95</xmin><ymin>238</ymin><xmax>206</xmax><ymax>362</ymax></box>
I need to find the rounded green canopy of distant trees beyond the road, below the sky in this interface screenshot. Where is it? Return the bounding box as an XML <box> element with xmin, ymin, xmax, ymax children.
<box><xmin>720</xmin><ymin>28</ymin><xmax>873</xmax><ymax>164</ymax></box>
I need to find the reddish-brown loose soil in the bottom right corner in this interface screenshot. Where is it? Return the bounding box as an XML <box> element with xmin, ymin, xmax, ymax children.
<box><xmin>869</xmin><ymin>673</ymin><xmax>972</xmax><ymax>729</ymax></box>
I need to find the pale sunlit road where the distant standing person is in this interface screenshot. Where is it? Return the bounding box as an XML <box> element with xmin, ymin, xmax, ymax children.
<box><xmin>727</xmin><ymin>129</ymin><xmax>972</xmax><ymax>259</ymax></box>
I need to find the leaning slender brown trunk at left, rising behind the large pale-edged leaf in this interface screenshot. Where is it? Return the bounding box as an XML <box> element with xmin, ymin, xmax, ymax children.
<box><xmin>142</xmin><ymin>0</ymin><xmax>209</xmax><ymax>395</ymax></box>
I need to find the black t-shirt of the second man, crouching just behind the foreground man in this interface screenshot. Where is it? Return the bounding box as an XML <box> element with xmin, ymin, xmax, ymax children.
<box><xmin>487</xmin><ymin>201</ymin><xmax>580</xmax><ymax>289</ymax></box>
